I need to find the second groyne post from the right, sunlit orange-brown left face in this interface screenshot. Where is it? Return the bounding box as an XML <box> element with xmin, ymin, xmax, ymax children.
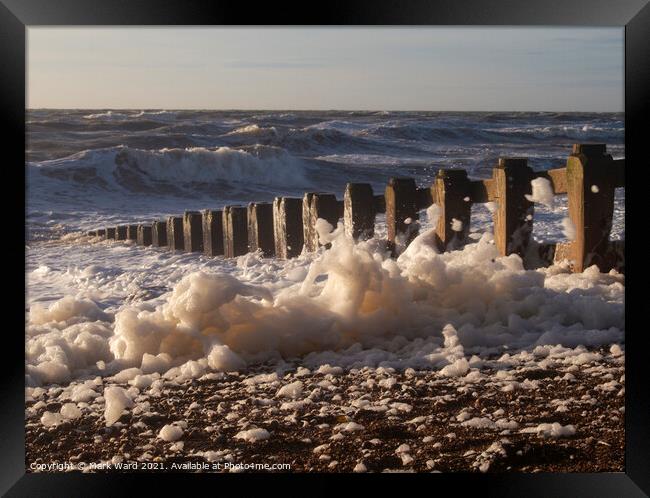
<box><xmin>492</xmin><ymin>158</ymin><xmax>534</xmax><ymax>258</ymax></box>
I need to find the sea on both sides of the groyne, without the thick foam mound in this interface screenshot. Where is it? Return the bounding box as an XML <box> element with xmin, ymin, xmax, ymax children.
<box><xmin>25</xmin><ymin>109</ymin><xmax>625</xmax><ymax>388</ymax></box>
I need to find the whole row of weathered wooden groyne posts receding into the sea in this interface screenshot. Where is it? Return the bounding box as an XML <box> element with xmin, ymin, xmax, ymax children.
<box><xmin>88</xmin><ymin>144</ymin><xmax>625</xmax><ymax>272</ymax></box>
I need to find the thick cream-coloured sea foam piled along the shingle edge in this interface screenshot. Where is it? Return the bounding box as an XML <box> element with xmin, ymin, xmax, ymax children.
<box><xmin>26</xmin><ymin>223</ymin><xmax>624</xmax><ymax>386</ymax></box>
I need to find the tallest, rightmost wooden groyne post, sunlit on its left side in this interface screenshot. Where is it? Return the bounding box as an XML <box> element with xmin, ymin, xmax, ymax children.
<box><xmin>566</xmin><ymin>144</ymin><xmax>615</xmax><ymax>272</ymax></box>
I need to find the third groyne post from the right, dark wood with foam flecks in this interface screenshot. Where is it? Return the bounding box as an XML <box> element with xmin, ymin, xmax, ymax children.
<box><xmin>430</xmin><ymin>169</ymin><xmax>472</xmax><ymax>251</ymax></box>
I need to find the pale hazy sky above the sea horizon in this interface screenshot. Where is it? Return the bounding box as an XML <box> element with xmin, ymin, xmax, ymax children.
<box><xmin>27</xmin><ymin>27</ymin><xmax>624</xmax><ymax>112</ymax></box>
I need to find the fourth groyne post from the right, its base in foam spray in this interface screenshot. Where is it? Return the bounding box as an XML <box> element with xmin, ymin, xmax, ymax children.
<box><xmin>384</xmin><ymin>178</ymin><xmax>418</xmax><ymax>255</ymax></box>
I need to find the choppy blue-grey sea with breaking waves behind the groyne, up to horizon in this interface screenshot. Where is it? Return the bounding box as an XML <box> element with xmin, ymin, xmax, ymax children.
<box><xmin>27</xmin><ymin>110</ymin><xmax>624</xmax><ymax>239</ymax></box>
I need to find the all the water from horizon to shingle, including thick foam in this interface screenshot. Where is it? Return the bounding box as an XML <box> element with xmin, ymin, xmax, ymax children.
<box><xmin>26</xmin><ymin>110</ymin><xmax>625</xmax><ymax>385</ymax></box>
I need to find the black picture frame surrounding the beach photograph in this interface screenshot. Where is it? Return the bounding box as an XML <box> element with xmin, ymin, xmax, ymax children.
<box><xmin>0</xmin><ymin>0</ymin><xmax>650</xmax><ymax>497</ymax></box>
